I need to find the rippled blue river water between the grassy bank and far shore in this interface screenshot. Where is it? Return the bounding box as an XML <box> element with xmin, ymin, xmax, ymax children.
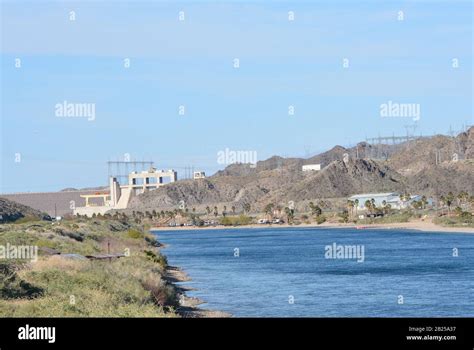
<box><xmin>154</xmin><ymin>228</ymin><xmax>474</xmax><ymax>317</ymax></box>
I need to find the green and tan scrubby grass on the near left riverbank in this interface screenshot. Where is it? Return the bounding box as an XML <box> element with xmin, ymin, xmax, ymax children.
<box><xmin>0</xmin><ymin>219</ymin><xmax>177</xmax><ymax>317</ymax></box>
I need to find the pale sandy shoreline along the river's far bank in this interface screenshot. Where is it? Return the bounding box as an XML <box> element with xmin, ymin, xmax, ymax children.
<box><xmin>150</xmin><ymin>221</ymin><xmax>474</xmax><ymax>234</ymax></box>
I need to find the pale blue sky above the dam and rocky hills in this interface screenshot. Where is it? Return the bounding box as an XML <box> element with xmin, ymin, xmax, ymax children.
<box><xmin>0</xmin><ymin>0</ymin><xmax>473</xmax><ymax>193</ymax></box>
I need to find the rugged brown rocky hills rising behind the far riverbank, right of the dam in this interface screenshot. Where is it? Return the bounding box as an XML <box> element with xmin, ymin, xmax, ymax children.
<box><xmin>127</xmin><ymin>127</ymin><xmax>474</xmax><ymax>210</ymax></box>
